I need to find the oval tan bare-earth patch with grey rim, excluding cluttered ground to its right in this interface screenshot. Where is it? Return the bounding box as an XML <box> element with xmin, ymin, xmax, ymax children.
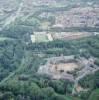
<box><xmin>38</xmin><ymin>56</ymin><xmax>82</xmax><ymax>80</ymax></box>
